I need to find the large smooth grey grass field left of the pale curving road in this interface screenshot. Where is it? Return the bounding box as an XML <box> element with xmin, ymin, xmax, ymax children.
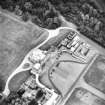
<box><xmin>0</xmin><ymin>14</ymin><xmax>46</xmax><ymax>92</ymax></box>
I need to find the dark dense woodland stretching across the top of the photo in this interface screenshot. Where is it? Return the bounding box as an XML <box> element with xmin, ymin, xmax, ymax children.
<box><xmin>0</xmin><ymin>0</ymin><xmax>105</xmax><ymax>47</ymax></box>
